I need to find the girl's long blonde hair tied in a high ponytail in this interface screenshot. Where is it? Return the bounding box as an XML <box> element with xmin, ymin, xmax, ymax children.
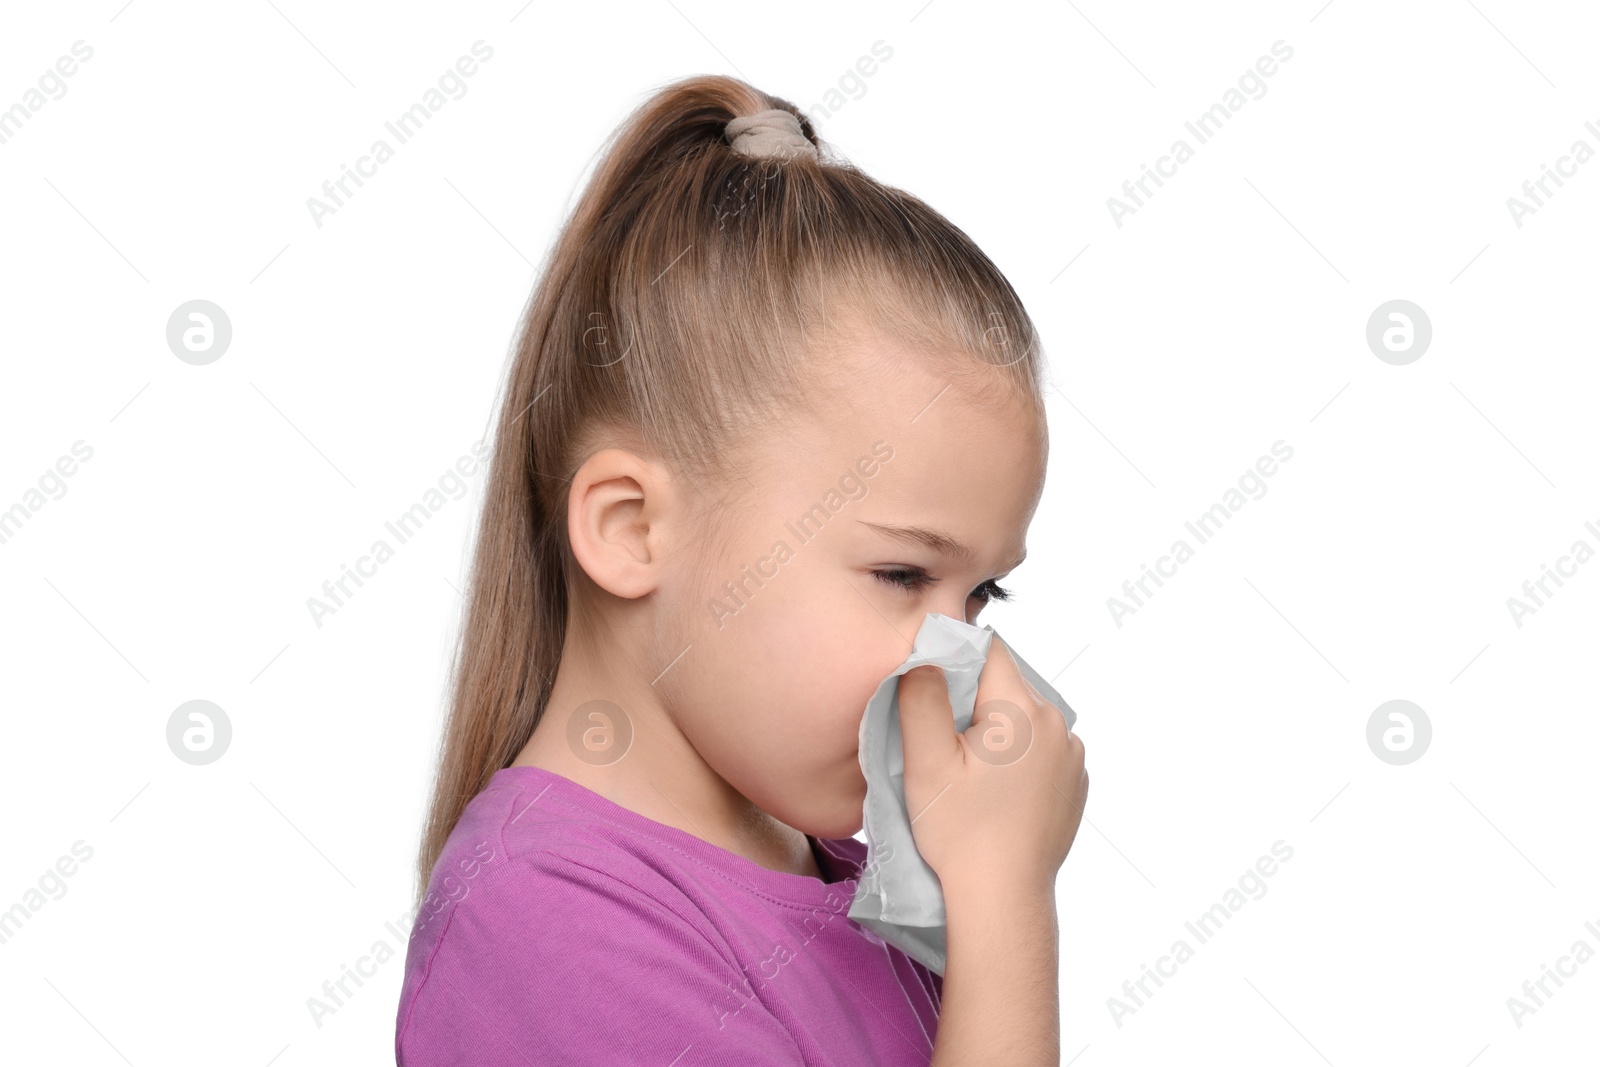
<box><xmin>416</xmin><ymin>77</ymin><xmax>1043</xmax><ymax>899</ymax></box>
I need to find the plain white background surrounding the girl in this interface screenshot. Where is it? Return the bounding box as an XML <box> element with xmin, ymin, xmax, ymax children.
<box><xmin>0</xmin><ymin>0</ymin><xmax>1600</xmax><ymax>1067</ymax></box>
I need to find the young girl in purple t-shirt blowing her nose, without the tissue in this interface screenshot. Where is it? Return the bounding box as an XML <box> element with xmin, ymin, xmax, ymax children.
<box><xmin>395</xmin><ymin>77</ymin><xmax>1088</xmax><ymax>1067</ymax></box>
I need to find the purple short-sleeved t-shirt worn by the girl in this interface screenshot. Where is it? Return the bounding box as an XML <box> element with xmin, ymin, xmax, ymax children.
<box><xmin>395</xmin><ymin>766</ymin><xmax>942</xmax><ymax>1067</ymax></box>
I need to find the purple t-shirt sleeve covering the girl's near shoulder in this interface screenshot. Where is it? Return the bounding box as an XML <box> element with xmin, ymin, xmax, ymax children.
<box><xmin>395</xmin><ymin>849</ymin><xmax>805</xmax><ymax>1067</ymax></box>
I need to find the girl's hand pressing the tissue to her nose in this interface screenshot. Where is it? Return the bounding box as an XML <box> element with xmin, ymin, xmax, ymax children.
<box><xmin>899</xmin><ymin>637</ymin><xmax>1090</xmax><ymax>891</ymax></box>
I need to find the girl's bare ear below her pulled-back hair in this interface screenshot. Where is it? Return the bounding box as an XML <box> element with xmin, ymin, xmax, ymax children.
<box><xmin>566</xmin><ymin>448</ymin><xmax>678</xmax><ymax>600</ymax></box>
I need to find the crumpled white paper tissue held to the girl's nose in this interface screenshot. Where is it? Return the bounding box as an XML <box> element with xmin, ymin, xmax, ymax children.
<box><xmin>848</xmin><ymin>613</ymin><xmax>1078</xmax><ymax>974</ymax></box>
